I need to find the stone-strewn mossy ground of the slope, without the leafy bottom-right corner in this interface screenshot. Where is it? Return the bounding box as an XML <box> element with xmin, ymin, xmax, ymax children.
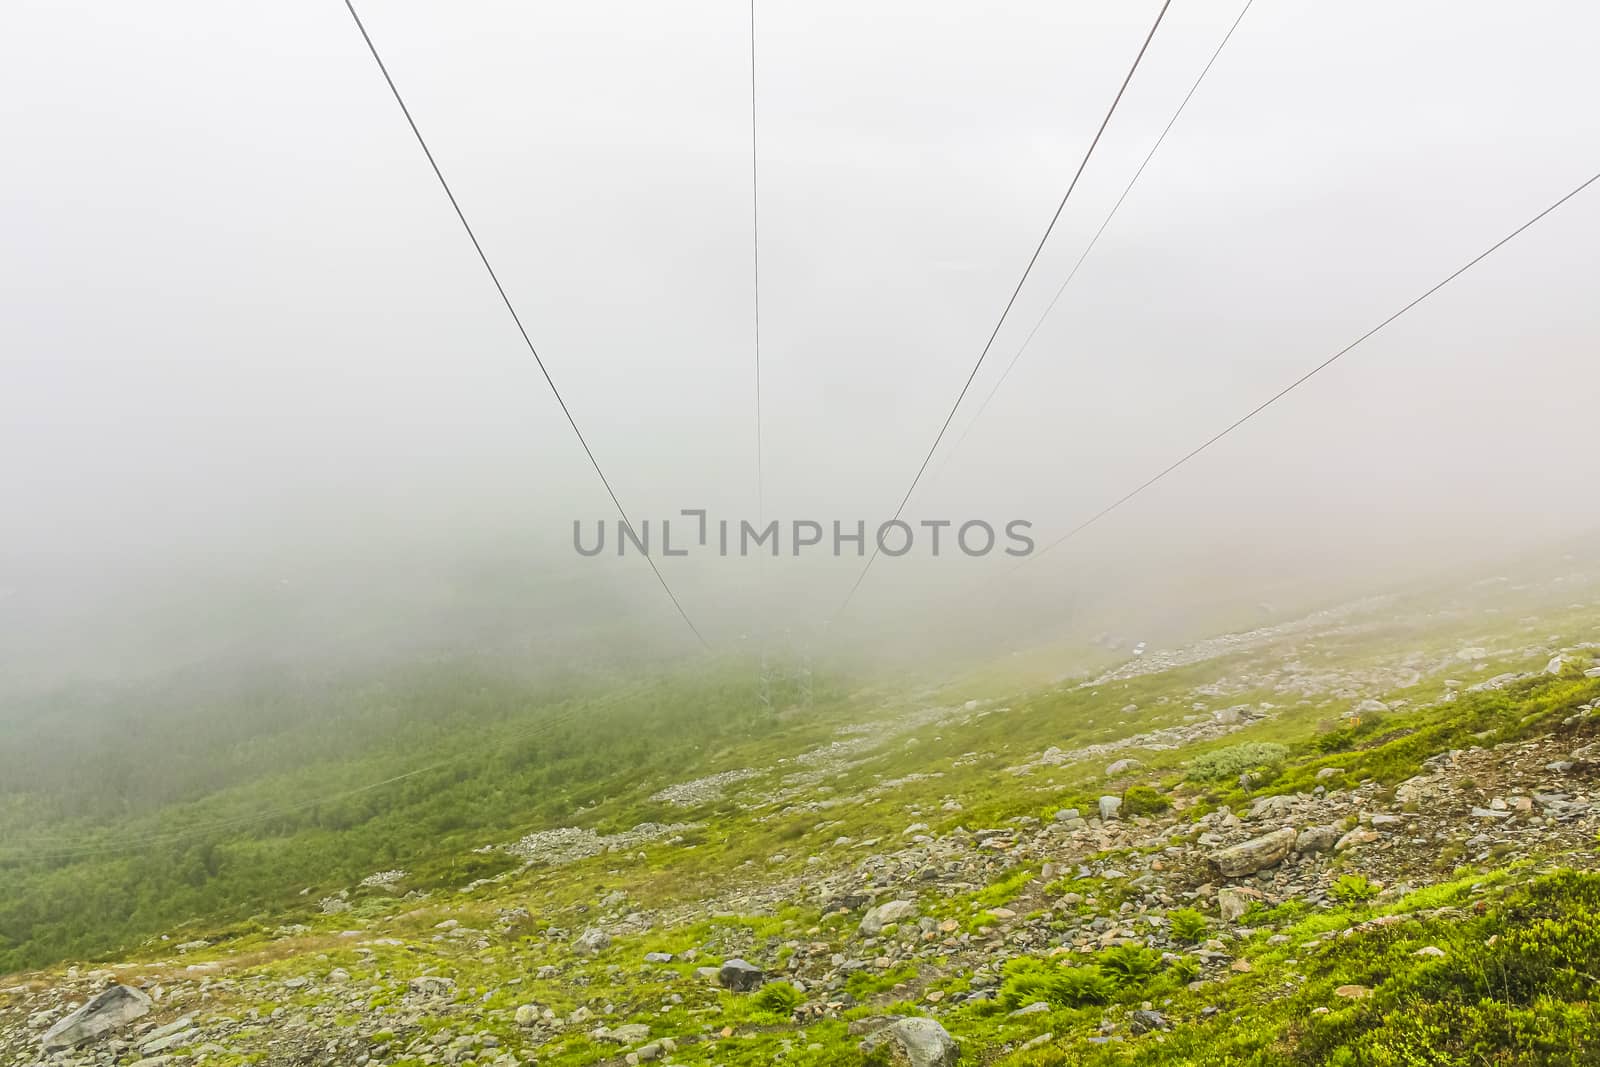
<box><xmin>0</xmin><ymin>585</ymin><xmax>1600</xmax><ymax>1067</ymax></box>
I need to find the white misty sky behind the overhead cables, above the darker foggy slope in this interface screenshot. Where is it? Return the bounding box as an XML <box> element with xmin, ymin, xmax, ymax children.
<box><xmin>0</xmin><ymin>0</ymin><xmax>1600</xmax><ymax>659</ymax></box>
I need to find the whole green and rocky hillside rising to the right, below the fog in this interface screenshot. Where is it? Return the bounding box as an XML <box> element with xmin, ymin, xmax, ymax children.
<box><xmin>0</xmin><ymin>574</ymin><xmax>1600</xmax><ymax>1067</ymax></box>
